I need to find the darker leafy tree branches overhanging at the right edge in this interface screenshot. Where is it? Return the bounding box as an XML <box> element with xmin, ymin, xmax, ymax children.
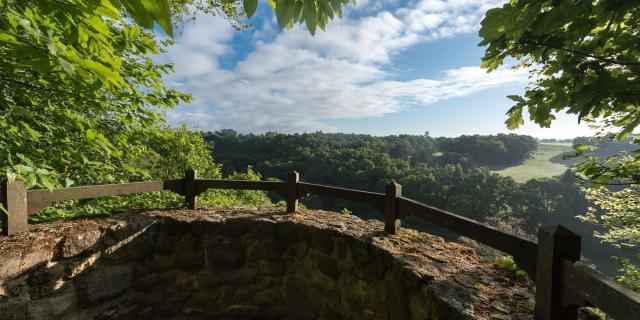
<box><xmin>480</xmin><ymin>0</ymin><xmax>640</xmax><ymax>184</ymax></box>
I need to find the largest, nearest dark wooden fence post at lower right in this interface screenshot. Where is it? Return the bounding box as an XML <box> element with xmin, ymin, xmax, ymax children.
<box><xmin>535</xmin><ymin>225</ymin><xmax>580</xmax><ymax>320</ymax></box>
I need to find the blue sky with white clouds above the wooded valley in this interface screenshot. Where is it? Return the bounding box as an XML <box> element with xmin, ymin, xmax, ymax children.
<box><xmin>158</xmin><ymin>0</ymin><xmax>592</xmax><ymax>138</ymax></box>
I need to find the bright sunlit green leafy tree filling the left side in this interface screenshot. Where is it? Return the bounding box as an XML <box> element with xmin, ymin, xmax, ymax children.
<box><xmin>0</xmin><ymin>0</ymin><xmax>348</xmax><ymax>188</ymax></box>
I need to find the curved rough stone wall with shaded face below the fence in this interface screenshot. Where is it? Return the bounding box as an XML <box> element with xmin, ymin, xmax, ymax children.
<box><xmin>0</xmin><ymin>208</ymin><xmax>533</xmax><ymax>320</ymax></box>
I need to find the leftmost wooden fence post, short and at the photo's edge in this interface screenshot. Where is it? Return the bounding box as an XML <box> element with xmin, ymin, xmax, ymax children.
<box><xmin>0</xmin><ymin>180</ymin><xmax>29</xmax><ymax>235</ymax></box>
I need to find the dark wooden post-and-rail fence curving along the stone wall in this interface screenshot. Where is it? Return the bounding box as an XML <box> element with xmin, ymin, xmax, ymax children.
<box><xmin>0</xmin><ymin>170</ymin><xmax>640</xmax><ymax>320</ymax></box>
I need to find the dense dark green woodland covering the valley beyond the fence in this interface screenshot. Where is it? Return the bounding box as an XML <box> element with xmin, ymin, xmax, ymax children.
<box><xmin>203</xmin><ymin>130</ymin><xmax>636</xmax><ymax>273</ymax></box>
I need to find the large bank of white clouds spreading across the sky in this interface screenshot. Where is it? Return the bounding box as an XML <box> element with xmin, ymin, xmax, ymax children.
<box><xmin>162</xmin><ymin>0</ymin><xmax>526</xmax><ymax>132</ymax></box>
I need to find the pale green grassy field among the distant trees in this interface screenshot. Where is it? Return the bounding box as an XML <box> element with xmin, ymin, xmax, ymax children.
<box><xmin>492</xmin><ymin>144</ymin><xmax>572</xmax><ymax>182</ymax></box>
